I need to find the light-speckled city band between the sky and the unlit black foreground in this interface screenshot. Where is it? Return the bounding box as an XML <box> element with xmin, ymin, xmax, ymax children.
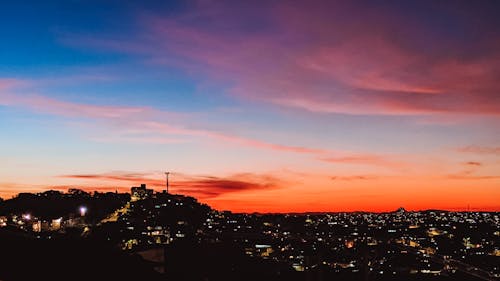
<box><xmin>0</xmin><ymin>184</ymin><xmax>500</xmax><ymax>281</ymax></box>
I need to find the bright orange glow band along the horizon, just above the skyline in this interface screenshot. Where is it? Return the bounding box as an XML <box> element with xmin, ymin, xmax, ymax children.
<box><xmin>2</xmin><ymin>175</ymin><xmax>500</xmax><ymax>213</ymax></box>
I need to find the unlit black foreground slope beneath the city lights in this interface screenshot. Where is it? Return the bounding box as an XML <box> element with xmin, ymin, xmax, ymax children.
<box><xmin>0</xmin><ymin>229</ymin><xmax>486</xmax><ymax>281</ymax></box>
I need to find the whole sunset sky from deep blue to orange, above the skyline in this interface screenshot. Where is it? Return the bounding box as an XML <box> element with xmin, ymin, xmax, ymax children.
<box><xmin>0</xmin><ymin>0</ymin><xmax>500</xmax><ymax>212</ymax></box>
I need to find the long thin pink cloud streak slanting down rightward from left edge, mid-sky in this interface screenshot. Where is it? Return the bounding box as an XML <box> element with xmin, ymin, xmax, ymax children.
<box><xmin>0</xmin><ymin>81</ymin><xmax>398</xmax><ymax>166</ymax></box>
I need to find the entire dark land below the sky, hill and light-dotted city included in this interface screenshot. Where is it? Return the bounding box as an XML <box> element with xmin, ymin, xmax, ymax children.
<box><xmin>0</xmin><ymin>185</ymin><xmax>500</xmax><ymax>281</ymax></box>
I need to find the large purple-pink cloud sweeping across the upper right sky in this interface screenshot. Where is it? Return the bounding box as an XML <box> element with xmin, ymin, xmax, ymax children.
<box><xmin>66</xmin><ymin>1</ymin><xmax>500</xmax><ymax>116</ymax></box>
